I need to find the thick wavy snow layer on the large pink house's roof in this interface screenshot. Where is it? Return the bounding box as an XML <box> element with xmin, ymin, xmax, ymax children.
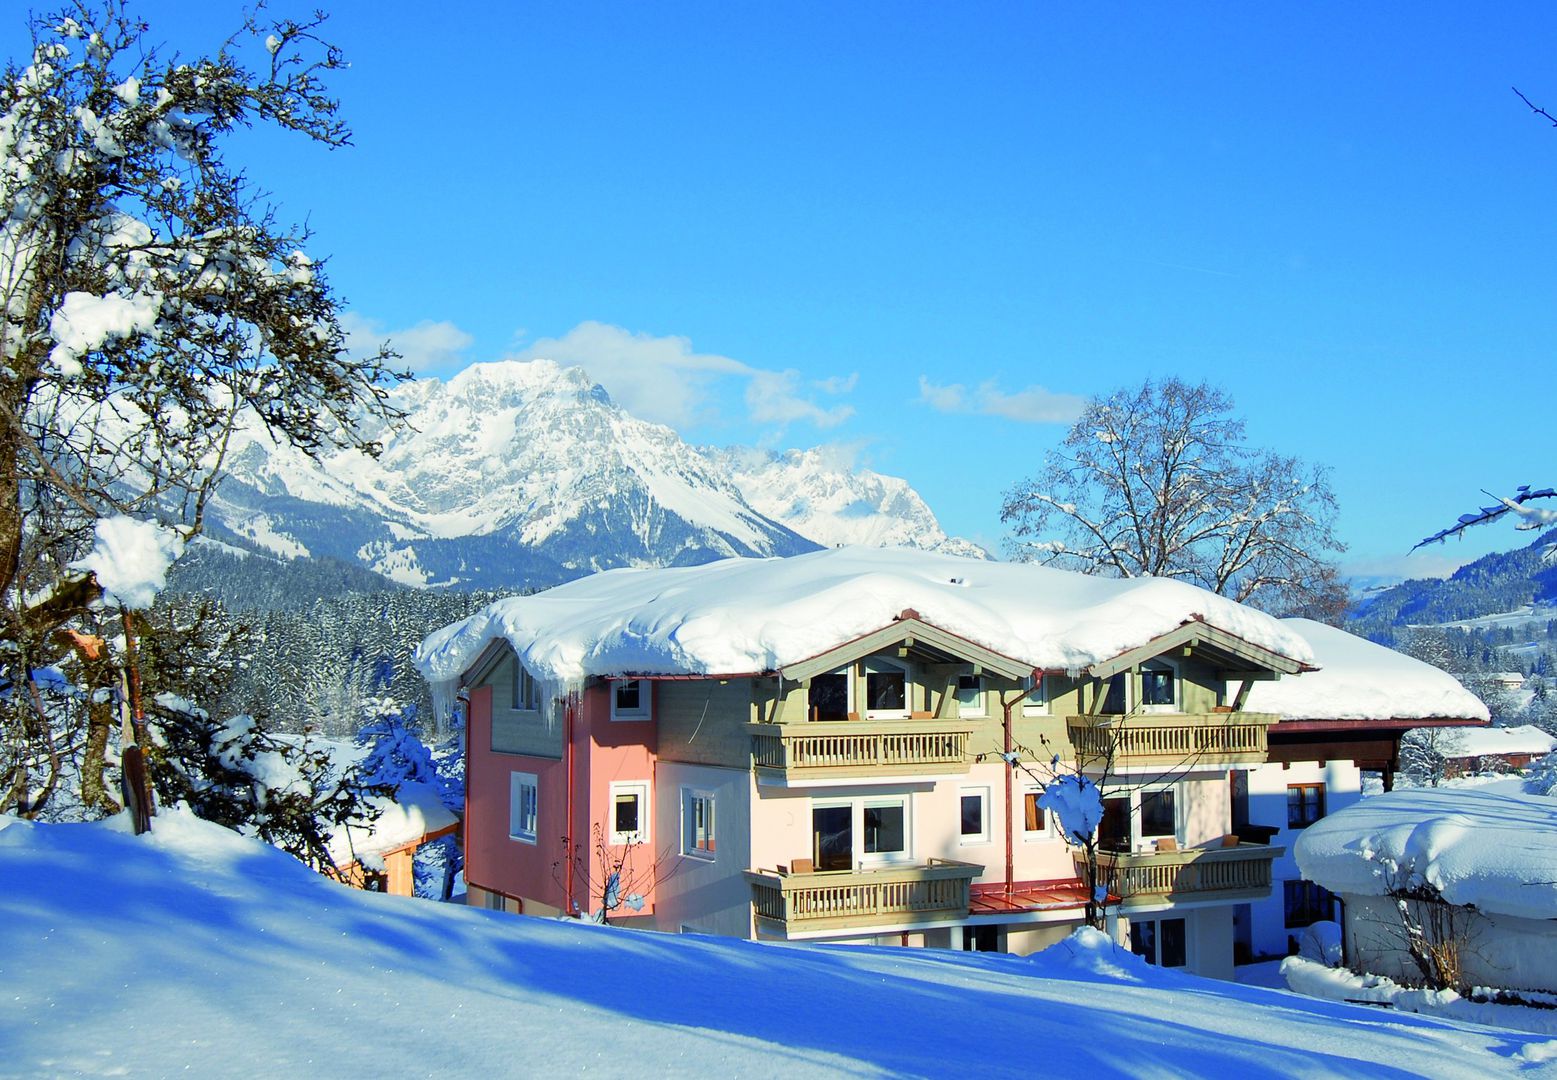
<box><xmin>417</xmin><ymin>548</ymin><xmax>1313</xmax><ymax>683</ymax></box>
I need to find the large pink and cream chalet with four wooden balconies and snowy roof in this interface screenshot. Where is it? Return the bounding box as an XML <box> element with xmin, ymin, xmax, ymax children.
<box><xmin>419</xmin><ymin>548</ymin><xmax>1313</xmax><ymax>977</ymax></box>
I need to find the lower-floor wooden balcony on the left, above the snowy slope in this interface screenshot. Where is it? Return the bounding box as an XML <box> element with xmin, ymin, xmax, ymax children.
<box><xmin>746</xmin><ymin>859</ymin><xmax>984</xmax><ymax>934</ymax></box>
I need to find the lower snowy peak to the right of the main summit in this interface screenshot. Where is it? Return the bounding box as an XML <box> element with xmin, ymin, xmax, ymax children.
<box><xmin>704</xmin><ymin>447</ymin><xmax>989</xmax><ymax>559</ymax></box>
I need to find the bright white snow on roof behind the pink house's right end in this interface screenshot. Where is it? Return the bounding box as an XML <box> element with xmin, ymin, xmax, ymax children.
<box><xmin>1246</xmin><ymin>619</ymin><xmax>1488</xmax><ymax>721</ymax></box>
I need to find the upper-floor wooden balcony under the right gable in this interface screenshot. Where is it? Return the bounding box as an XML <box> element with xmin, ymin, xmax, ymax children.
<box><xmin>1065</xmin><ymin>713</ymin><xmax>1280</xmax><ymax>772</ymax></box>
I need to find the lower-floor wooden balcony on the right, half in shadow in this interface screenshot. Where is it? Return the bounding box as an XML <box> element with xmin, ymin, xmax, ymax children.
<box><xmin>1073</xmin><ymin>843</ymin><xmax>1285</xmax><ymax>910</ymax></box>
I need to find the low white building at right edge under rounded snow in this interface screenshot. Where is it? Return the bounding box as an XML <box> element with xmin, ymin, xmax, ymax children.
<box><xmin>1297</xmin><ymin>787</ymin><xmax>1557</xmax><ymax>993</ymax></box>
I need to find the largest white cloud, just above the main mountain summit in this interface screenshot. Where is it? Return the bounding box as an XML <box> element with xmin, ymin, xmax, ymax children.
<box><xmin>514</xmin><ymin>321</ymin><xmax>855</xmax><ymax>430</ymax></box>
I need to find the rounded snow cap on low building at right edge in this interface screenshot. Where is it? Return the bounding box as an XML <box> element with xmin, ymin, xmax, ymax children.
<box><xmin>1294</xmin><ymin>787</ymin><xmax>1557</xmax><ymax>918</ymax></box>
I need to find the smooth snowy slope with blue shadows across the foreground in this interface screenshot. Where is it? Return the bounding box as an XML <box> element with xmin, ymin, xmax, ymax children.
<box><xmin>0</xmin><ymin>811</ymin><xmax>1557</xmax><ymax>1078</ymax></box>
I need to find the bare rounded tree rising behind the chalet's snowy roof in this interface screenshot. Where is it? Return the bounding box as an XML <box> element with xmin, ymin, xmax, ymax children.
<box><xmin>1001</xmin><ymin>378</ymin><xmax>1345</xmax><ymax>621</ymax></box>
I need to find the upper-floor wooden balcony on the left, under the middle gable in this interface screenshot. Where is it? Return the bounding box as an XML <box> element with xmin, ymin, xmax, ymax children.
<box><xmin>750</xmin><ymin>721</ymin><xmax>973</xmax><ymax>780</ymax></box>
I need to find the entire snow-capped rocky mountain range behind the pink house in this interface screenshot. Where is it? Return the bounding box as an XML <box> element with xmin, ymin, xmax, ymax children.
<box><xmin>210</xmin><ymin>359</ymin><xmax>972</xmax><ymax>588</ymax></box>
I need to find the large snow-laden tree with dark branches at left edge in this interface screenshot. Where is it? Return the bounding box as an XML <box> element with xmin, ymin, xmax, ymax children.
<box><xmin>0</xmin><ymin>0</ymin><xmax>400</xmax><ymax>846</ymax></box>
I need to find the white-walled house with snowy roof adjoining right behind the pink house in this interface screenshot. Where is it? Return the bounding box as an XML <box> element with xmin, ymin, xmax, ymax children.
<box><xmin>1232</xmin><ymin>619</ymin><xmax>1490</xmax><ymax>959</ymax></box>
